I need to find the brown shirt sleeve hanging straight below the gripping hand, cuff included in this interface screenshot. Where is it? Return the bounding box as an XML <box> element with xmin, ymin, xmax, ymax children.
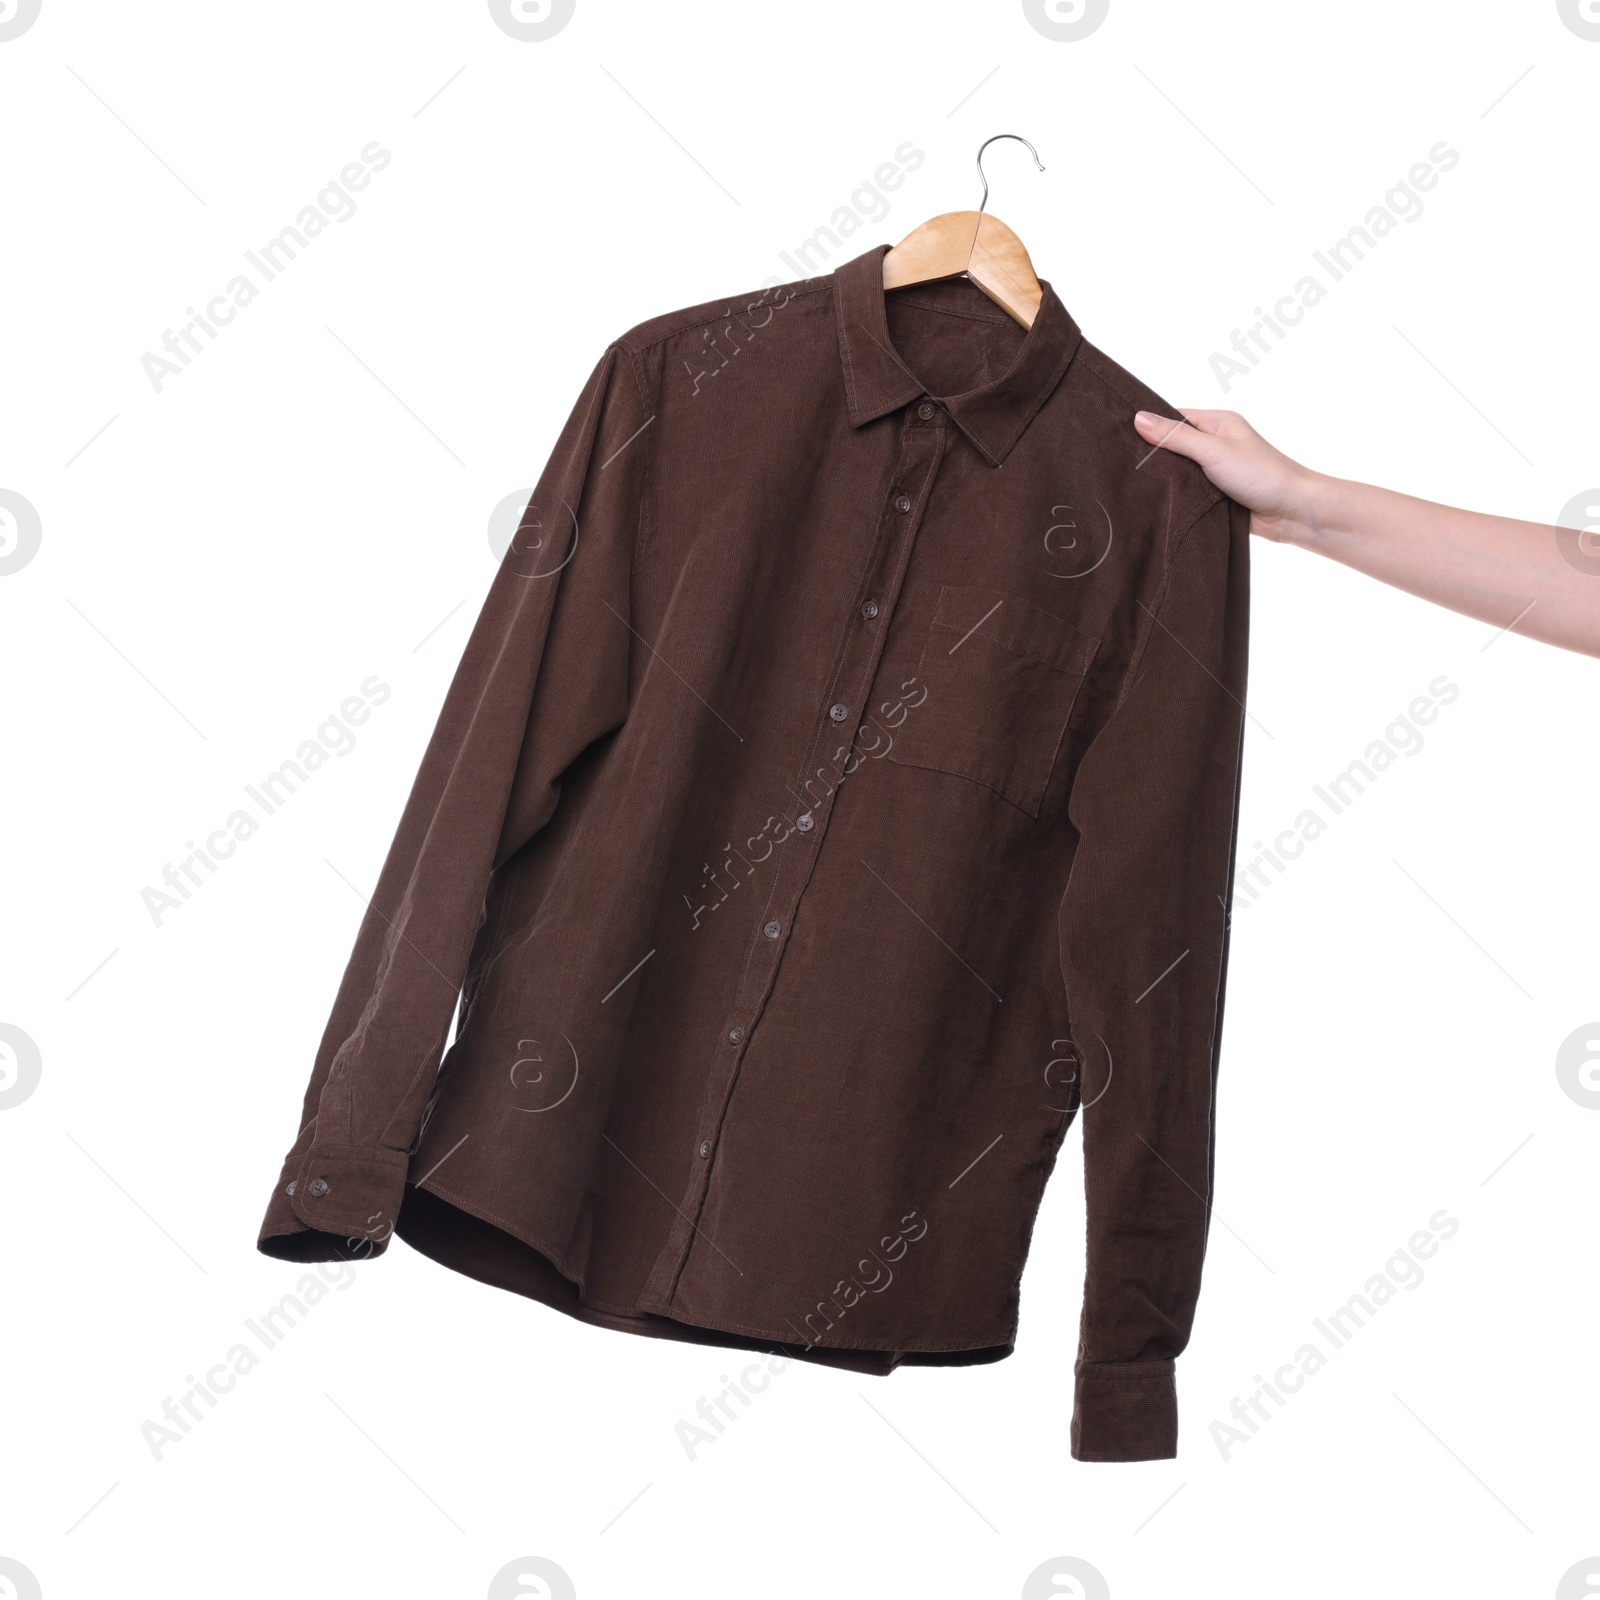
<box><xmin>1061</xmin><ymin>499</ymin><xmax>1250</xmax><ymax>1461</ymax></box>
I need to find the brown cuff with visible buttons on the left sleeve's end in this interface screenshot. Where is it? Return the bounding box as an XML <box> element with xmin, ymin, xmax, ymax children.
<box><xmin>256</xmin><ymin>1146</ymin><xmax>411</xmax><ymax>1261</ymax></box>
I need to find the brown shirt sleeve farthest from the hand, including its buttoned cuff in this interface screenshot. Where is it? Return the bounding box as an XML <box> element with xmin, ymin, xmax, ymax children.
<box><xmin>258</xmin><ymin>346</ymin><xmax>653</xmax><ymax>1261</ymax></box>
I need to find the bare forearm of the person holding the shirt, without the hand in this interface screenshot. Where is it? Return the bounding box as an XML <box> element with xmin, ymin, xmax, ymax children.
<box><xmin>1256</xmin><ymin>472</ymin><xmax>1600</xmax><ymax>656</ymax></box>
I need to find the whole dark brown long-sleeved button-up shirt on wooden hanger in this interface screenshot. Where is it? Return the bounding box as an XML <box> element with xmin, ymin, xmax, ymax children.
<box><xmin>261</xmin><ymin>246</ymin><xmax>1248</xmax><ymax>1461</ymax></box>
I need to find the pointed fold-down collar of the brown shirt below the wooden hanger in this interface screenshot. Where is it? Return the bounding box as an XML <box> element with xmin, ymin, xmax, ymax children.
<box><xmin>834</xmin><ymin>236</ymin><xmax>1083</xmax><ymax>467</ymax></box>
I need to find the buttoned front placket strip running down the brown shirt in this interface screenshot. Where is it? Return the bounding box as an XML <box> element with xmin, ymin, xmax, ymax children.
<box><xmin>646</xmin><ymin>414</ymin><xmax>946</xmax><ymax>1312</ymax></box>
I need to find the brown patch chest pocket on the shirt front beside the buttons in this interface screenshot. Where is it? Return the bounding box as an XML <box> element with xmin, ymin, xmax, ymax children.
<box><xmin>886</xmin><ymin>584</ymin><xmax>1099</xmax><ymax>816</ymax></box>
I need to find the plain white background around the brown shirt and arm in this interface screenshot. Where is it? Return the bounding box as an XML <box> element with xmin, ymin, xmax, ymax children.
<box><xmin>0</xmin><ymin>0</ymin><xmax>1600</xmax><ymax>1600</ymax></box>
